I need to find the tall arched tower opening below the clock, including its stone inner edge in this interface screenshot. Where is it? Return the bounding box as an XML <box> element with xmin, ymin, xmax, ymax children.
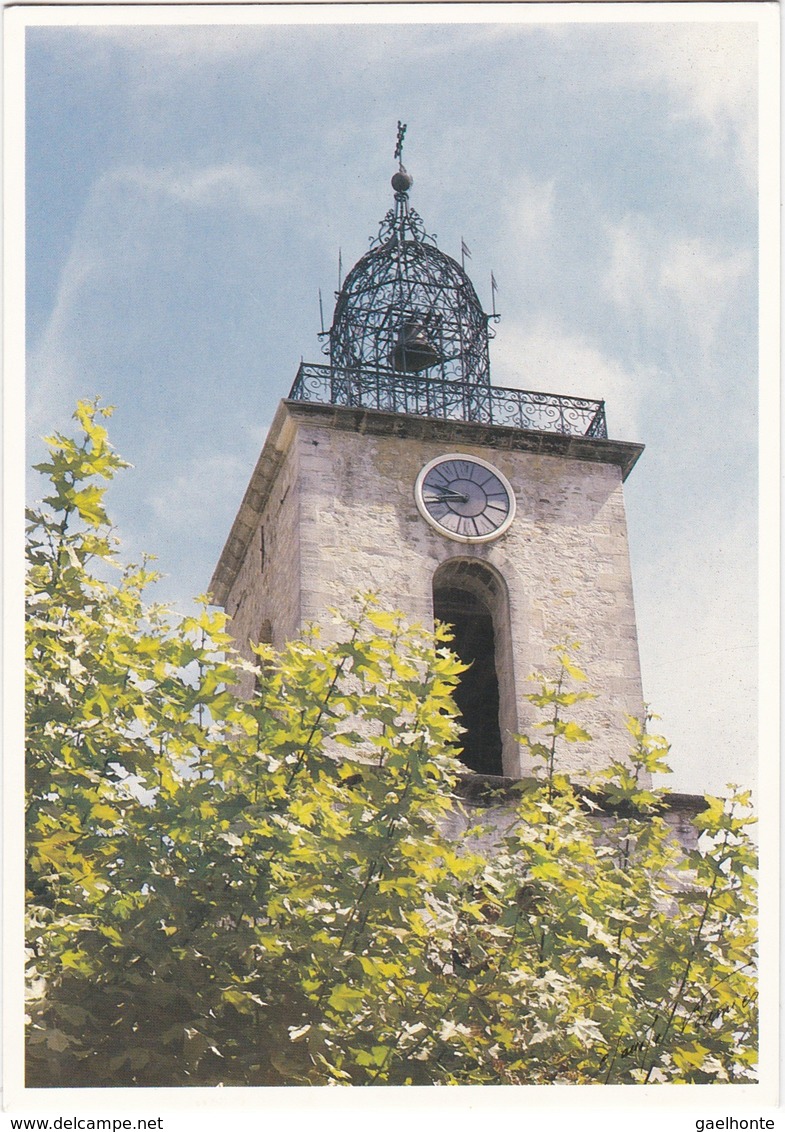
<box><xmin>434</xmin><ymin>559</ymin><xmax>514</xmax><ymax>774</ymax></box>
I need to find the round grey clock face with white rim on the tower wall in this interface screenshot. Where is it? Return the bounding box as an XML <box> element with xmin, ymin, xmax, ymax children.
<box><xmin>415</xmin><ymin>453</ymin><xmax>515</xmax><ymax>542</ymax></box>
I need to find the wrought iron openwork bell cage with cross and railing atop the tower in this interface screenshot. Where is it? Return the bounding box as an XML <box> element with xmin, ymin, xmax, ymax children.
<box><xmin>290</xmin><ymin>122</ymin><xmax>607</xmax><ymax>437</ymax></box>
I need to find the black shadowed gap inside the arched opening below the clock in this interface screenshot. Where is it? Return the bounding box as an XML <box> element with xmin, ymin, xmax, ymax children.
<box><xmin>434</xmin><ymin>575</ymin><xmax>503</xmax><ymax>774</ymax></box>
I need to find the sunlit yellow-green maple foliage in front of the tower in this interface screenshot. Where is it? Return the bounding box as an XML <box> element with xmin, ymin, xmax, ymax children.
<box><xmin>27</xmin><ymin>403</ymin><xmax>756</xmax><ymax>1087</ymax></box>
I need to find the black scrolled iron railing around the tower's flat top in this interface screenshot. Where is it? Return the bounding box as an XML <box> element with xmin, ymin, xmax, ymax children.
<box><xmin>289</xmin><ymin>362</ymin><xmax>608</xmax><ymax>438</ymax></box>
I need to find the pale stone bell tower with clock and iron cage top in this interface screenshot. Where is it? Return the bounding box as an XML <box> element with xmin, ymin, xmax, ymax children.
<box><xmin>211</xmin><ymin>127</ymin><xmax>642</xmax><ymax>778</ymax></box>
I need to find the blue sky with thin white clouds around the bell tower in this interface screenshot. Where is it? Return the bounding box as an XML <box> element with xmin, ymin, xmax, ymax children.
<box><xmin>18</xmin><ymin>5</ymin><xmax>776</xmax><ymax>792</ymax></box>
